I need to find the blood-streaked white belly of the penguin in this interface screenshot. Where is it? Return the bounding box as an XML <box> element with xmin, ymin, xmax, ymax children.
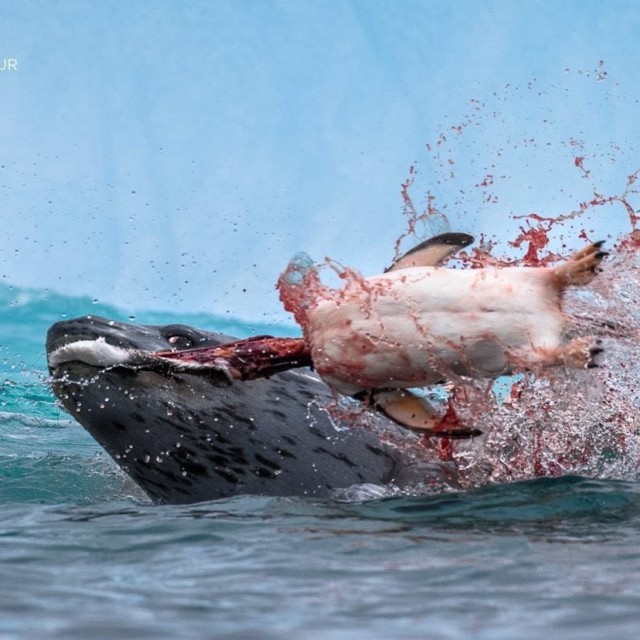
<box><xmin>305</xmin><ymin>267</ymin><xmax>564</xmax><ymax>394</ymax></box>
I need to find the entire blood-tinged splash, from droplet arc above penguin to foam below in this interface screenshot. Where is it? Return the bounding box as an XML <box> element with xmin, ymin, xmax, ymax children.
<box><xmin>282</xmin><ymin>61</ymin><xmax>640</xmax><ymax>488</ymax></box>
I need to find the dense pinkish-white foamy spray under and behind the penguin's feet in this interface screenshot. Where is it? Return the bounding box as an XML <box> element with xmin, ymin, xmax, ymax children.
<box><xmin>453</xmin><ymin>246</ymin><xmax>640</xmax><ymax>485</ymax></box>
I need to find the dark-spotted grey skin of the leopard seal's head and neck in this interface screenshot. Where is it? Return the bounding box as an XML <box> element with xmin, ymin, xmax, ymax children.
<box><xmin>47</xmin><ymin>316</ymin><xmax>436</xmax><ymax>504</ymax></box>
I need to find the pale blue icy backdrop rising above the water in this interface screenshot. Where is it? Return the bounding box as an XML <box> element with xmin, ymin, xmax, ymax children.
<box><xmin>0</xmin><ymin>0</ymin><xmax>640</xmax><ymax>322</ymax></box>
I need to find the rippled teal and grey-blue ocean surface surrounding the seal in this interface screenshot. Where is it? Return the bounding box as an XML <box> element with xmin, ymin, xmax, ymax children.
<box><xmin>0</xmin><ymin>285</ymin><xmax>640</xmax><ymax>640</ymax></box>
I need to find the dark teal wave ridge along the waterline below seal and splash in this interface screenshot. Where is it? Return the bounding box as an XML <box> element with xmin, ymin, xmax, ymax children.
<box><xmin>28</xmin><ymin>476</ymin><xmax>640</xmax><ymax>539</ymax></box>
